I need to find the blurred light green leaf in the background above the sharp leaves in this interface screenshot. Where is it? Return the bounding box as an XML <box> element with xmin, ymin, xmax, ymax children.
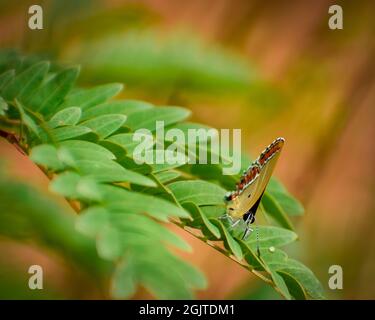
<box><xmin>65</xmin><ymin>31</ymin><xmax>257</xmax><ymax>94</ymax></box>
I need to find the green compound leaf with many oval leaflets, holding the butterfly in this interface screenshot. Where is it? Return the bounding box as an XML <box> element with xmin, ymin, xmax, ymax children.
<box><xmin>0</xmin><ymin>54</ymin><xmax>324</xmax><ymax>299</ymax></box>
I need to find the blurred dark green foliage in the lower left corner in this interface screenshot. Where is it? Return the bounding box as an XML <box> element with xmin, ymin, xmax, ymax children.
<box><xmin>0</xmin><ymin>164</ymin><xmax>113</xmax><ymax>299</ymax></box>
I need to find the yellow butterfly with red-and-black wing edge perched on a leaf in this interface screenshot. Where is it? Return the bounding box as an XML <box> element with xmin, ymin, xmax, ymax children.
<box><xmin>224</xmin><ymin>138</ymin><xmax>285</xmax><ymax>240</ymax></box>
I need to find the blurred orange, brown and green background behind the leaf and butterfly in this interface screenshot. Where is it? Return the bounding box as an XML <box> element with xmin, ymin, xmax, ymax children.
<box><xmin>0</xmin><ymin>0</ymin><xmax>375</xmax><ymax>299</ymax></box>
